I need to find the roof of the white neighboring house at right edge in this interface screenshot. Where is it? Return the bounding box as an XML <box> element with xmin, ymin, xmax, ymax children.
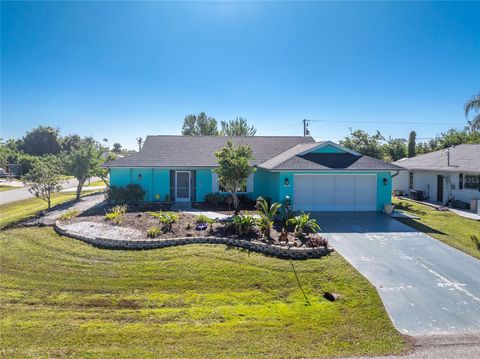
<box><xmin>394</xmin><ymin>143</ymin><xmax>480</xmax><ymax>173</ymax></box>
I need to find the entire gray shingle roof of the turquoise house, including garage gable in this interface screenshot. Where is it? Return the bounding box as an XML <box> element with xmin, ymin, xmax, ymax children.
<box><xmin>104</xmin><ymin>136</ymin><xmax>403</xmax><ymax>171</ymax></box>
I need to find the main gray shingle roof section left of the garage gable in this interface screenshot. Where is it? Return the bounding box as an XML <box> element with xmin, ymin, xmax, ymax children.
<box><xmin>105</xmin><ymin>136</ymin><xmax>316</xmax><ymax>167</ymax></box>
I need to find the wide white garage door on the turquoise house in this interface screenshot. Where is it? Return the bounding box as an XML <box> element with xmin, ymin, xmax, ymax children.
<box><xmin>293</xmin><ymin>175</ymin><xmax>377</xmax><ymax>211</ymax></box>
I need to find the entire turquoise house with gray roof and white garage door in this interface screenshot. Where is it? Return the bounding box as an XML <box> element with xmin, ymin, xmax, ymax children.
<box><xmin>105</xmin><ymin>136</ymin><xmax>403</xmax><ymax>211</ymax></box>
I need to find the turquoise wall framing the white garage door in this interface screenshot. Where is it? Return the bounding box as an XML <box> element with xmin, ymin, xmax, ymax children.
<box><xmin>275</xmin><ymin>171</ymin><xmax>392</xmax><ymax>211</ymax></box>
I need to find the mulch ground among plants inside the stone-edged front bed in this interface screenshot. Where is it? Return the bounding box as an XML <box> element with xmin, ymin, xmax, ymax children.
<box><xmin>68</xmin><ymin>210</ymin><xmax>320</xmax><ymax>247</ymax></box>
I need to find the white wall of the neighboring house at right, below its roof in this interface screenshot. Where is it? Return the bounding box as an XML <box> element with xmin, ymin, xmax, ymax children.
<box><xmin>393</xmin><ymin>170</ymin><xmax>480</xmax><ymax>203</ymax></box>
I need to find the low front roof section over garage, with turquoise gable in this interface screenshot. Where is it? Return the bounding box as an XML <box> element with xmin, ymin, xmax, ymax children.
<box><xmin>260</xmin><ymin>153</ymin><xmax>404</xmax><ymax>171</ymax></box>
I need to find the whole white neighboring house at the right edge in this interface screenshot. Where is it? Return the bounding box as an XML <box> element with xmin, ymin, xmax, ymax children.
<box><xmin>393</xmin><ymin>144</ymin><xmax>480</xmax><ymax>204</ymax></box>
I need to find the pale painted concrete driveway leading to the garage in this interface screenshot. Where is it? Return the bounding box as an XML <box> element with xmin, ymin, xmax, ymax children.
<box><xmin>312</xmin><ymin>212</ymin><xmax>480</xmax><ymax>336</ymax></box>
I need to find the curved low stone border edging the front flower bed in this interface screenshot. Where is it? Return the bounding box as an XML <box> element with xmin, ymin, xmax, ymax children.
<box><xmin>53</xmin><ymin>221</ymin><xmax>333</xmax><ymax>259</ymax></box>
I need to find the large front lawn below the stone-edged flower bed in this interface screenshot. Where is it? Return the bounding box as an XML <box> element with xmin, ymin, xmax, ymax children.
<box><xmin>0</xmin><ymin>228</ymin><xmax>409</xmax><ymax>358</ymax></box>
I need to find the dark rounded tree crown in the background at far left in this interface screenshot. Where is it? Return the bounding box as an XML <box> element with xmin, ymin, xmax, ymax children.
<box><xmin>19</xmin><ymin>126</ymin><xmax>62</xmax><ymax>156</ymax></box>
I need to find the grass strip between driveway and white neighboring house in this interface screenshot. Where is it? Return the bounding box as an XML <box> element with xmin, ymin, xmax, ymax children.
<box><xmin>393</xmin><ymin>198</ymin><xmax>480</xmax><ymax>259</ymax></box>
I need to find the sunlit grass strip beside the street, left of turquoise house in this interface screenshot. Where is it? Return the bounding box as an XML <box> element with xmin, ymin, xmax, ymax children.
<box><xmin>0</xmin><ymin>191</ymin><xmax>101</xmax><ymax>228</ymax></box>
